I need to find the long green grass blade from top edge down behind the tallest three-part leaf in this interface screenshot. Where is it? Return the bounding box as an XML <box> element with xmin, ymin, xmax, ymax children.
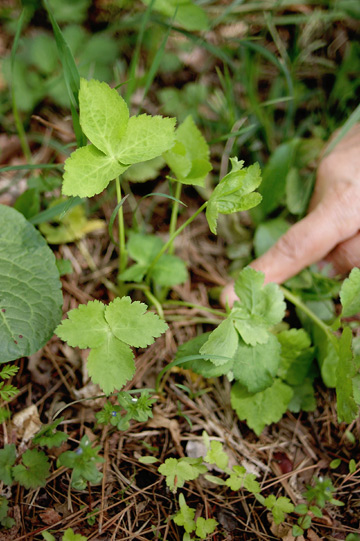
<box><xmin>44</xmin><ymin>0</ymin><xmax>87</xmax><ymax>147</ymax></box>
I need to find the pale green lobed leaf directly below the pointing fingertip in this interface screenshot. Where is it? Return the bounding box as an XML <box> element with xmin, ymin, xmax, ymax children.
<box><xmin>230</xmin><ymin>267</ymin><xmax>285</xmax><ymax>346</ymax></box>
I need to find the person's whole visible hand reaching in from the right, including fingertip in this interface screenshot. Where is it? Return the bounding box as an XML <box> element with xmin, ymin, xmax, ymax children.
<box><xmin>220</xmin><ymin>124</ymin><xmax>360</xmax><ymax>306</ymax></box>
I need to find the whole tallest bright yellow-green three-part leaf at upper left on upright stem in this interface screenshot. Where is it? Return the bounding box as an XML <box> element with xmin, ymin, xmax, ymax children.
<box><xmin>62</xmin><ymin>79</ymin><xmax>175</xmax><ymax>197</ymax></box>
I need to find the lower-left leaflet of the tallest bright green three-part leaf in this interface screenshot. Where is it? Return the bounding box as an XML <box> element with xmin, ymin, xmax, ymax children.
<box><xmin>62</xmin><ymin>145</ymin><xmax>128</xmax><ymax>197</ymax></box>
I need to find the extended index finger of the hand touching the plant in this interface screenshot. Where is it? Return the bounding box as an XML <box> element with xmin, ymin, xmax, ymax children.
<box><xmin>251</xmin><ymin>182</ymin><xmax>360</xmax><ymax>284</ymax></box>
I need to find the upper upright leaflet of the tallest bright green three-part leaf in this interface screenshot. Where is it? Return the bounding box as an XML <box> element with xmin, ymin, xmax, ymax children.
<box><xmin>79</xmin><ymin>79</ymin><xmax>129</xmax><ymax>160</ymax></box>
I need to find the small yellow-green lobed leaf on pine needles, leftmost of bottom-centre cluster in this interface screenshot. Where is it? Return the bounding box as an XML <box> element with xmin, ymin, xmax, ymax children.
<box><xmin>158</xmin><ymin>457</ymin><xmax>207</xmax><ymax>493</ymax></box>
